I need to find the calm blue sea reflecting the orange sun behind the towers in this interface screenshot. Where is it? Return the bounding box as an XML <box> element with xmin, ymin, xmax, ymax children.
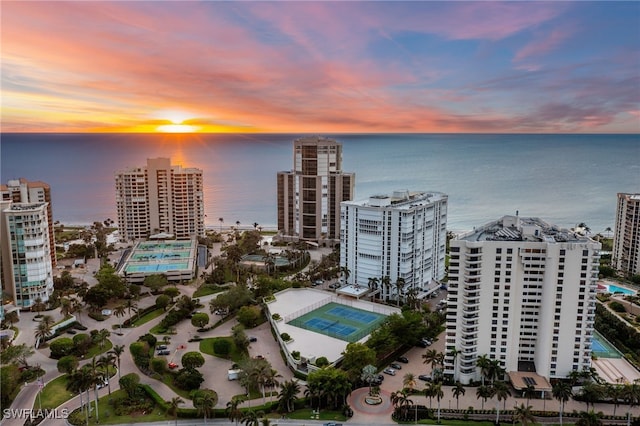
<box><xmin>0</xmin><ymin>134</ymin><xmax>640</xmax><ymax>232</ymax></box>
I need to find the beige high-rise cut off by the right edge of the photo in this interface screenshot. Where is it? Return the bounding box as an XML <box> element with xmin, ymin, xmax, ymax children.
<box><xmin>612</xmin><ymin>193</ymin><xmax>640</xmax><ymax>275</ymax></box>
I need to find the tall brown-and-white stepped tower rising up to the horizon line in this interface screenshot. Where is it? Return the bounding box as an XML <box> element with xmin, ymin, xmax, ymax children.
<box><xmin>277</xmin><ymin>136</ymin><xmax>355</xmax><ymax>244</ymax></box>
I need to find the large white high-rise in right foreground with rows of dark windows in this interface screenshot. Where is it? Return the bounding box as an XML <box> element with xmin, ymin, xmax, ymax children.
<box><xmin>445</xmin><ymin>214</ymin><xmax>601</xmax><ymax>391</ymax></box>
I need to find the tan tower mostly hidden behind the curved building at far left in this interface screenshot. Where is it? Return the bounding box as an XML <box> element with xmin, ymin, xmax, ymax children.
<box><xmin>0</xmin><ymin>178</ymin><xmax>57</xmax><ymax>270</ymax></box>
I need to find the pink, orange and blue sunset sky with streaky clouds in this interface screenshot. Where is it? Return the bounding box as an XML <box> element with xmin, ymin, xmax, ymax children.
<box><xmin>0</xmin><ymin>1</ymin><xmax>640</xmax><ymax>133</ymax></box>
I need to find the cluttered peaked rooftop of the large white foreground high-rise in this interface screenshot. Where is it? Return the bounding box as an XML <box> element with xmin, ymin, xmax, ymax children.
<box><xmin>458</xmin><ymin>215</ymin><xmax>590</xmax><ymax>243</ymax></box>
